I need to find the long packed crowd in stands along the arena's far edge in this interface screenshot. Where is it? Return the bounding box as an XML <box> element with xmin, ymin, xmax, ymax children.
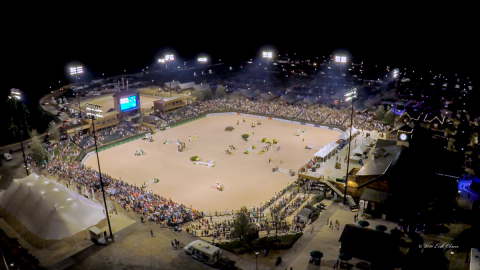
<box><xmin>155</xmin><ymin>98</ymin><xmax>389</xmax><ymax>131</ymax></box>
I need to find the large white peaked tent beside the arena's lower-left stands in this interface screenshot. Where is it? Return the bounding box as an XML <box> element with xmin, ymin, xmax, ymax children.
<box><xmin>0</xmin><ymin>173</ymin><xmax>105</xmax><ymax>240</ymax></box>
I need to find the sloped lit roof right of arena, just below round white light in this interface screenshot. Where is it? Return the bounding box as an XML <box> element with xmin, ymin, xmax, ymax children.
<box><xmin>357</xmin><ymin>145</ymin><xmax>401</xmax><ymax>176</ymax></box>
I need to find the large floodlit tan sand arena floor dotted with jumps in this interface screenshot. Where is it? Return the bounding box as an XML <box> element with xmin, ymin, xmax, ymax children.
<box><xmin>85</xmin><ymin>115</ymin><xmax>340</xmax><ymax>214</ymax></box>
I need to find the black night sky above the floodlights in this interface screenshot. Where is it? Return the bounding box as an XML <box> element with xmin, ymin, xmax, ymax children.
<box><xmin>0</xmin><ymin>7</ymin><xmax>478</xmax><ymax>141</ymax></box>
